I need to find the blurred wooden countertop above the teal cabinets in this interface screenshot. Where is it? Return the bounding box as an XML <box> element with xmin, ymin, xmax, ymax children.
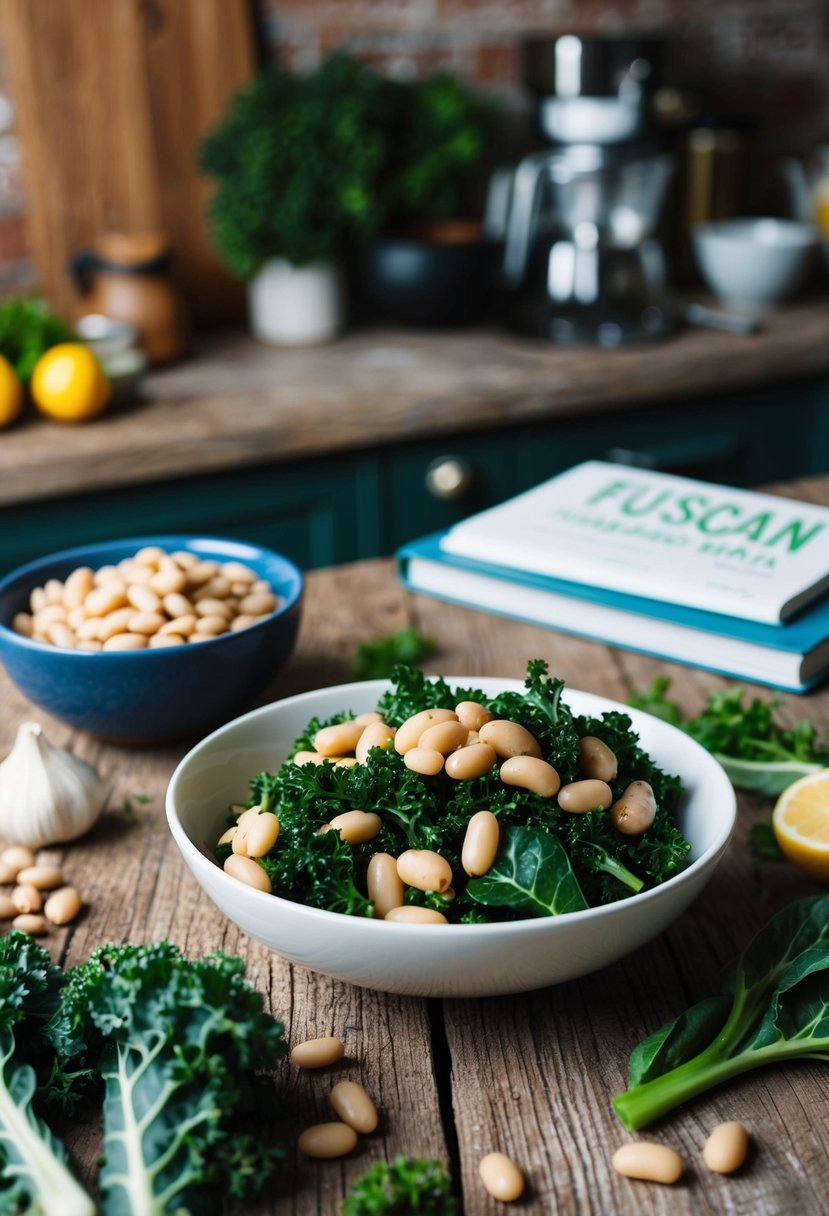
<box><xmin>0</xmin><ymin>306</ymin><xmax>829</xmax><ymax>505</ymax></box>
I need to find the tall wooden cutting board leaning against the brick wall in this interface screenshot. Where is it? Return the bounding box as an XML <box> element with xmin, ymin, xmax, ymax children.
<box><xmin>0</xmin><ymin>0</ymin><xmax>258</xmax><ymax>322</ymax></box>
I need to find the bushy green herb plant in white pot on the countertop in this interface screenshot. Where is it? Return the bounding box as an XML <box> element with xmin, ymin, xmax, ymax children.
<box><xmin>198</xmin><ymin>52</ymin><xmax>387</xmax><ymax>343</ymax></box>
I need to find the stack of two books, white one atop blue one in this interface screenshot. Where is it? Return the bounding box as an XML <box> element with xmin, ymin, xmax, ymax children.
<box><xmin>397</xmin><ymin>461</ymin><xmax>829</xmax><ymax>692</ymax></box>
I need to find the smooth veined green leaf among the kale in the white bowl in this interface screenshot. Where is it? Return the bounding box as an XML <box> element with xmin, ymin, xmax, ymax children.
<box><xmin>467</xmin><ymin>828</ymin><xmax>587</xmax><ymax>916</ymax></box>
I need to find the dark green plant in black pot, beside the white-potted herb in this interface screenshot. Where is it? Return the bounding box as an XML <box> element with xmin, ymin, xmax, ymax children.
<box><xmin>356</xmin><ymin>72</ymin><xmax>497</xmax><ymax>326</ymax></box>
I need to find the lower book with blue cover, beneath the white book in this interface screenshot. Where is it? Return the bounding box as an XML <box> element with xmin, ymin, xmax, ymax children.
<box><xmin>396</xmin><ymin>533</ymin><xmax>829</xmax><ymax>692</ymax></box>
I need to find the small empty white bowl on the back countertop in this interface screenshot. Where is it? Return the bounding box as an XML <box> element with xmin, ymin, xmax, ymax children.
<box><xmin>692</xmin><ymin>219</ymin><xmax>818</xmax><ymax>314</ymax></box>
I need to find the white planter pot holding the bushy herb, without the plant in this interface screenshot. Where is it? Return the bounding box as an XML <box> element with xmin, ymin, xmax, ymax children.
<box><xmin>248</xmin><ymin>258</ymin><xmax>345</xmax><ymax>345</ymax></box>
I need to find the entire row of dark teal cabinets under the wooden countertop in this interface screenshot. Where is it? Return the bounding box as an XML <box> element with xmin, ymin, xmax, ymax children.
<box><xmin>0</xmin><ymin>377</ymin><xmax>829</xmax><ymax>572</ymax></box>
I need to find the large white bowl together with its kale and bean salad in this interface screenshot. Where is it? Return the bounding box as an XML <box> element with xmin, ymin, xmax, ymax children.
<box><xmin>167</xmin><ymin>660</ymin><xmax>735</xmax><ymax>996</ymax></box>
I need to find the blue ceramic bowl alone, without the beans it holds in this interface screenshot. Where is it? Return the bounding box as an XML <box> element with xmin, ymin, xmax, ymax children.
<box><xmin>0</xmin><ymin>535</ymin><xmax>303</xmax><ymax>743</ymax></box>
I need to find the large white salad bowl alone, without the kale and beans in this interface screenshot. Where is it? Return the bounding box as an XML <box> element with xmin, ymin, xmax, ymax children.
<box><xmin>167</xmin><ymin>676</ymin><xmax>737</xmax><ymax>997</ymax></box>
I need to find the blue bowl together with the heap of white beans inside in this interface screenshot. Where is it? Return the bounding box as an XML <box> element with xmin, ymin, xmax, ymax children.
<box><xmin>0</xmin><ymin>535</ymin><xmax>303</xmax><ymax>744</ymax></box>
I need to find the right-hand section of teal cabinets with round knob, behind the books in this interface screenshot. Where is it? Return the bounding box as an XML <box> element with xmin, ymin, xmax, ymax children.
<box><xmin>380</xmin><ymin>379</ymin><xmax>829</xmax><ymax>552</ymax></box>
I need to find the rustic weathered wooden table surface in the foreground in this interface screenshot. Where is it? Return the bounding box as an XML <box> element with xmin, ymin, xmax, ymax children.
<box><xmin>0</xmin><ymin>482</ymin><xmax>829</xmax><ymax>1216</ymax></box>
